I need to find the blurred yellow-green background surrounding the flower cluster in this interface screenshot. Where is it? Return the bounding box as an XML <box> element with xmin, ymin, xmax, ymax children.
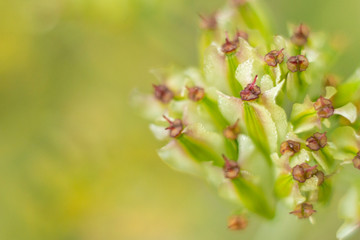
<box><xmin>0</xmin><ymin>0</ymin><xmax>360</xmax><ymax>240</ymax></box>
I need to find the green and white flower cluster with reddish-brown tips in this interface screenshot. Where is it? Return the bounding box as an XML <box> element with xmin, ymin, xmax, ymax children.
<box><xmin>137</xmin><ymin>0</ymin><xmax>360</xmax><ymax>238</ymax></box>
